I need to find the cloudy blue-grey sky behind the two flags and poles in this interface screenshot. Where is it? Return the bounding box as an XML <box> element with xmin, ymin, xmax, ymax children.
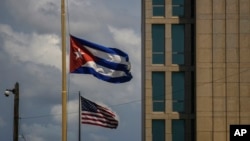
<box><xmin>0</xmin><ymin>0</ymin><xmax>141</xmax><ymax>141</ymax></box>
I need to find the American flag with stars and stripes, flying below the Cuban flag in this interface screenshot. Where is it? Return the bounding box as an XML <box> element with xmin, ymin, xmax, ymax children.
<box><xmin>81</xmin><ymin>96</ymin><xmax>118</xmax><ymax>128</ymax></box>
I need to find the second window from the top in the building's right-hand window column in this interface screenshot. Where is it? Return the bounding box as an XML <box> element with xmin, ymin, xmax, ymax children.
<box><xmin>171</xmin><ymin>24</ymin><xmax>185</xmax><ymax>65</ymax></box>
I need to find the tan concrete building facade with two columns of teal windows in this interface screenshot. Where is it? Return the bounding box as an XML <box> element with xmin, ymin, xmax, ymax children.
<box><xmin>142</xmin><ymin>0</ymin><xmax>250</xmax><ymax>141</ymax></box>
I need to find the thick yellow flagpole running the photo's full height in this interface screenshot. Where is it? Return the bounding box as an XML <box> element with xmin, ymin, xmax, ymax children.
<box><xmin>61</xmin><ymin>0</ymin><xmax>67</xmax><ymax>141</ymax></box>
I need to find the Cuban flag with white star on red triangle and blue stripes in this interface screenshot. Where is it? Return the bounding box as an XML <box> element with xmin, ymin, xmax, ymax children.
<box><xmin>70</xmin><ymin>35</ymin><xmax>132</xmax><ymax>83</ymax></box>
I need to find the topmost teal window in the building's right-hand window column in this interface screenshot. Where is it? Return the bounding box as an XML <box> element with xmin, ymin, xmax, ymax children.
<box><xmin>172</xmin><ymin>0</ymin><xmax>184</xmax><ymax>17</ymax></box>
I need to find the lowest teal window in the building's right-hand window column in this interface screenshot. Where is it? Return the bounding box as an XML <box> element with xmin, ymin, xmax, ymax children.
<box><xmin>172</xmin><ymin>119</ymin><xmax>185</xmax><ymax>141</ymax></box>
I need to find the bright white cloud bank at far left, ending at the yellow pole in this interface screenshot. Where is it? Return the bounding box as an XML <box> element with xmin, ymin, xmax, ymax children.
<box><xmin>0</xmin><ymin>24</ymin><xmax>66</xmax><ymax>69</ymax></box>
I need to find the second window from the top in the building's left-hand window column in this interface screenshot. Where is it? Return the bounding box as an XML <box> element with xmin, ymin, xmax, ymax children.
<box><xmin>152</xmin><ymin>24</ymin><xmax>165</xmax><ymax>64</ymax></box>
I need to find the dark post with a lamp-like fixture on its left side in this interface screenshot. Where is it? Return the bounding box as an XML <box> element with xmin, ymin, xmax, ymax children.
<box><xmin>4</xmin><ymin>82</ymin><xmax>19</xmax><ymax>141</ymax></box>
